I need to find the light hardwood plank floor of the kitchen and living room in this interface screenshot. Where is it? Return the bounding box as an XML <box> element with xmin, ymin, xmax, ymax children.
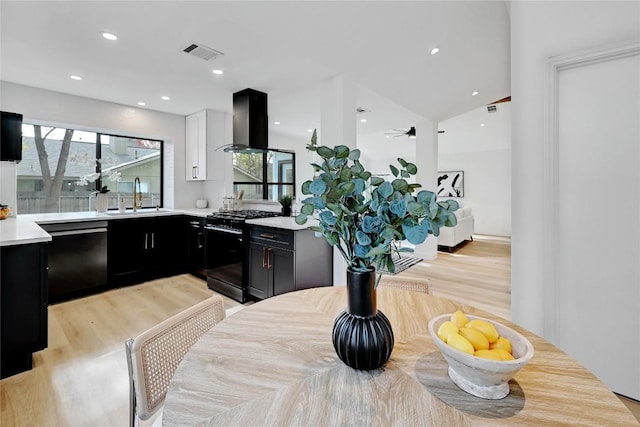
<box><xmin>0</xmin><ymin>236</ymin><xmax>640</xmax><ymax>427</ymax></box>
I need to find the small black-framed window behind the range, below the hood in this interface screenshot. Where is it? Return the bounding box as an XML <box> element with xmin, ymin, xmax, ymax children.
<box><xmin>233</xmin><ymin>150</ymin><xmax>296</xmax><ymax>202</ymax></box>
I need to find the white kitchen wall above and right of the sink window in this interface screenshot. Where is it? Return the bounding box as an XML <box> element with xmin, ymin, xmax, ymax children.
<box><xmin>0</xmin><ymin>81</ymin><xmax>208</xmax><ymax>208</ymax></box>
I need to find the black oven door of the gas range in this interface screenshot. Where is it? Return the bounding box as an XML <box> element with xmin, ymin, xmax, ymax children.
<box><xmin>204</xmin><ymin>224</ymin><xmax>245</xmax><ymax>302</ymax></box>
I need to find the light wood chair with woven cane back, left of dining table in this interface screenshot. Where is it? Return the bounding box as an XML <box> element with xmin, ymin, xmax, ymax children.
<box><xmin>125</xmin><ymin>295</ymin><xmax>225</xmax><ymax>427</ymax></box>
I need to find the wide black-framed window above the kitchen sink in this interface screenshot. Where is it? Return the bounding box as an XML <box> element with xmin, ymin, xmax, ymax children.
<box><xmin>17</xmin><ymin>124</ymin><xmax>162</xmax><ymax>214</ymax></box>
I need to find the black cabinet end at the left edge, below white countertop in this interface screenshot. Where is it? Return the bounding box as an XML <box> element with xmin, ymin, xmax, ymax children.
<box><xmin>0</xmin><ymin>243</ymin><xmax>48</xmax><ymax>378</ymax></box>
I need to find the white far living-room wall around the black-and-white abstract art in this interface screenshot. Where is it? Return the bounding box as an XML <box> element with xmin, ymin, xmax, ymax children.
<box><xmin>438</xmin><ymin>102</ymin><xmax>511</xmax><ymax>236</ymax></box>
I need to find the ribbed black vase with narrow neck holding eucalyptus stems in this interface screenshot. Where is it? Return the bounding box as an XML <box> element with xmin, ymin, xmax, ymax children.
<box><xmin>333</xmin><ymin>267</ymin><xmax>394</xmax><ymax>371</ymax></box>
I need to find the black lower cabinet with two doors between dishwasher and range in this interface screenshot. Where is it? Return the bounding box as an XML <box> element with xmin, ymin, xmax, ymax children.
<box><xmin>108</xmin><ymin>216</ymin><xmax>188</xmax><ymax>286</ymax></box>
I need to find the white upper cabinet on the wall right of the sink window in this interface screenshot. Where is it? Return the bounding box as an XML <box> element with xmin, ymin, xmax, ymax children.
<box><xmin>185</xmin><ymin>110</ymin><xmax>207</xmax><ymax>181</ymax></box>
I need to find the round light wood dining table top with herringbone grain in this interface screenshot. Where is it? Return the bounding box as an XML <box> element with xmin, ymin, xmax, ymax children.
<box><xmin>163</xmin><ymin>286</ymin><xmax>640</xmax><ymax>427</ymax></box>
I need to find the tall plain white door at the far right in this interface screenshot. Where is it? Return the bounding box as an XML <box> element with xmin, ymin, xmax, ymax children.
<box><xmin>555</xmin><ymin>47</ymin><xmax>640</xmax><ymax>399</ymax></box>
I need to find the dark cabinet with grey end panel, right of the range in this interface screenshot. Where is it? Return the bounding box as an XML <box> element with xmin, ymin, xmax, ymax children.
<box><xmin>247</xmin><ymin>226</ymin><xmax>333</xmax><ymax>299</ymax></box>
